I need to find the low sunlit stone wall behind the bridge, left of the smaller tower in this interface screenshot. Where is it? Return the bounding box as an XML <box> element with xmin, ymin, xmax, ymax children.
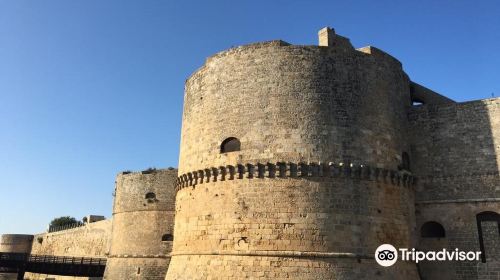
<box><xmin>25</xmin><ymin>220</ymin><xmax>111</xmax><ymax>280</ymax></box>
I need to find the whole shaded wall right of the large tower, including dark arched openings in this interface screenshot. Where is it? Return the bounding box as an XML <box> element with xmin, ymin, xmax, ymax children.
<box><xmin>409</xmin><ymin>99</ymin><xmax>500</xmax><ymax>279</ymax></box>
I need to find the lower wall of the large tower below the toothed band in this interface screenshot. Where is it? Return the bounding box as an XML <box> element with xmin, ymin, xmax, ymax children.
<box><xmin>167</xmin><ymin>177</ymin><xmax>416</xmax><ymax>279</ymax></box>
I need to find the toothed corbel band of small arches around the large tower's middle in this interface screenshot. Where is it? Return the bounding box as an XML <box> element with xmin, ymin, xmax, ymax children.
<box><xmin>176</xmin><ymin>162</ymin><xmax>416</xmax><ymax>191</ymax></box>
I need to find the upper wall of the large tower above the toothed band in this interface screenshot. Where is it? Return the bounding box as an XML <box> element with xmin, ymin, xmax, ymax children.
<box><xmin>179</xmin><ymin>37</ymin><xmax>410</xmax><ymax>174</ymax></box>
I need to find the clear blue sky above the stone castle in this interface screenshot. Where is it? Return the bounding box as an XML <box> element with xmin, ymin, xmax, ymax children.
<box><xmin>0</xmin><ymin>0</ymin><xmax>500</xmax><ymax>233</ymax></box>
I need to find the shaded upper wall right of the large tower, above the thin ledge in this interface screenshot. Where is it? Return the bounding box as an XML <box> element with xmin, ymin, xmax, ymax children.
<box><xmin>410</xmin><ymin>98</ymin><xmax>500</xmax><ymax>201</ymax></box>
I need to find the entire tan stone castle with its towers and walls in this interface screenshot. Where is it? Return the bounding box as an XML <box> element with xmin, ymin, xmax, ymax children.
<box><xmin>0</xmin><ymin>28</ymin><xmax>500</xmax><ymax>280</ymax></box>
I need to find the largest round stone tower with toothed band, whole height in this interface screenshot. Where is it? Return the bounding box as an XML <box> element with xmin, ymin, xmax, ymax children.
<box><xmin>166</xmin><ymin>28</ymin><xmax>418</xmax><ymax>280</ymax></box>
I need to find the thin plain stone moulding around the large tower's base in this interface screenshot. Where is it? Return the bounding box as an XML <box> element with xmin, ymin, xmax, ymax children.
<box><xmin>171</xmin><ymin>250</ymin><xmax>374</xmax><ymax>259</ymax></box>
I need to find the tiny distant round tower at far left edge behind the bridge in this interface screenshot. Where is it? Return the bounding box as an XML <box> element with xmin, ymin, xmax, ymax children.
<box><xmin>0</xmin><ymin>234</ymin><xmax>33</xmax><ymax>280</ymax></box>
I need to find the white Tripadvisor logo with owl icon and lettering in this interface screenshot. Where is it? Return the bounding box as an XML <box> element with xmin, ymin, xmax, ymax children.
<box><xmin>375</xmin><ymin>244</ymin><xmax>481</xmax><ymax>266</ymax></box>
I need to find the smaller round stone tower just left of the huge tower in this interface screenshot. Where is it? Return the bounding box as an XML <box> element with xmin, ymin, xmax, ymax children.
<box><xmin>104</xmin><ymin>168</ymin><xmax>177</xmax><ymax>280</ymax></box>
